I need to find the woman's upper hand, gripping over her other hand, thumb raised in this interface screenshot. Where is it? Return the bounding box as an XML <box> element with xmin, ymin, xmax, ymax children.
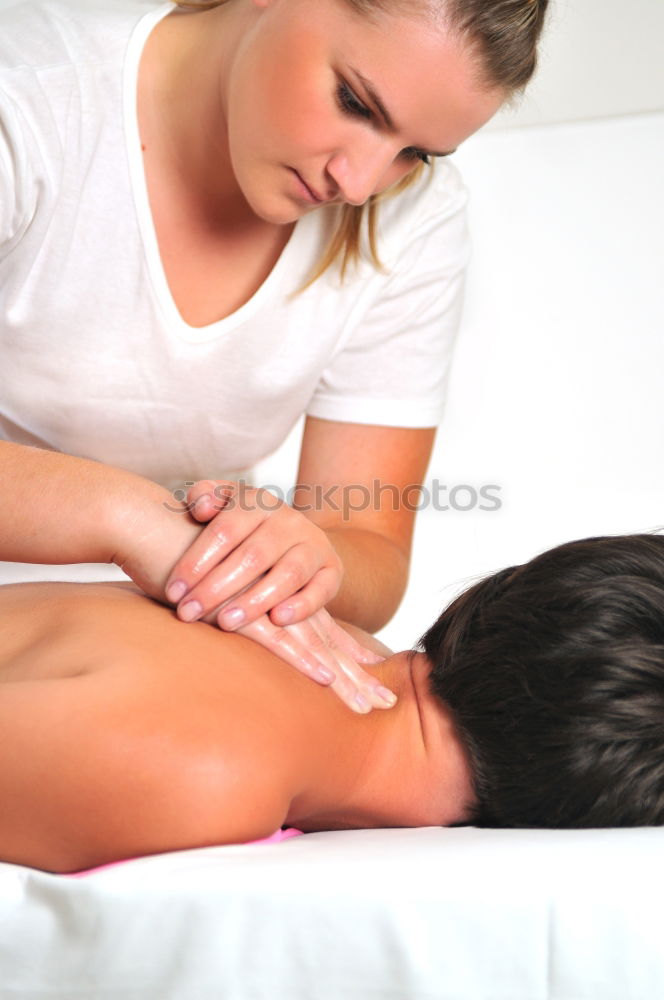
<box><xmin>166</xmin><ymin>480</ymin><xmax>343</xmax><ymax>631</ymax></box>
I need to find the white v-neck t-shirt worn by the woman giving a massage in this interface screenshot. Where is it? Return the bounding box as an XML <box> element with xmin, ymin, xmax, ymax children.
<box><xmin>0</xmin><ymin>0</ymin><xmax>468</xmax><ymax>487</ymax></box>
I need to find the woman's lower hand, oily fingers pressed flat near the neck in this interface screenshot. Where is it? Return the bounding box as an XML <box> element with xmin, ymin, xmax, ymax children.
<box><xmin>238</xmin><ymin>609</ymin><xmax>397</xmax><ymax>714</ymax></box>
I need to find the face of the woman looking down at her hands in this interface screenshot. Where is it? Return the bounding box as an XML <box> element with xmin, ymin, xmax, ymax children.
<box><xmin>222</xmin><ymin>0</ymin><xmax>504</xmax><ymax>224</ymax></box>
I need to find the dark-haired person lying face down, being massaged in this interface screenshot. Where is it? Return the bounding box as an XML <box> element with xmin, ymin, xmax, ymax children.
<box><xmin>0</xmin><ymin>535</ymin><xmax>664</xmax><ymax>872</ymax></box>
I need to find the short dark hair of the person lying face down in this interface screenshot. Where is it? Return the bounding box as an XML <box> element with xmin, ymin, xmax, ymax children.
<box><xmin>420</xmin><ymin>534</ymin><xmax>664</xmax><ymax>827</ymax></box>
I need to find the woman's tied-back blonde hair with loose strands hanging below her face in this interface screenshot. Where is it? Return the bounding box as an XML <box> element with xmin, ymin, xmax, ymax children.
<box><xmin>174</xmin><ymin>0</ymin><xmax>548</xmax><ymax>282</ymax></box>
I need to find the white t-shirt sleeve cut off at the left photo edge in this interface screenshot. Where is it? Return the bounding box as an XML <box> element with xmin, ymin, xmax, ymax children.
<box><xmin>0</xmin><ymin>93</ymin><xmax>34</xmax><ymax>260</ymax></box>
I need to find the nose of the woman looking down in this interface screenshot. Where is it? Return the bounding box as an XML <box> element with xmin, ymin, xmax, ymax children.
<box><xmin>327</xmin><ymin>135</ymin><xmax>399</xmax><ymax>205</ymax></box>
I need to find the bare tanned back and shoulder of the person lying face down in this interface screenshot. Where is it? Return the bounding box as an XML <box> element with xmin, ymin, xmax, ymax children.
<box><xmin>0</xmin><ymin>583</ymin><xmax>356</xmax><ymax>870</ymax></box>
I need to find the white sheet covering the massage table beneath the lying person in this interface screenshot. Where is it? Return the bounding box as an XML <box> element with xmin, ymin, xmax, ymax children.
<box><xmin>0</xmin><ymin>828</ymin><xmax>664</xmax><ymax>1000</ymax></box>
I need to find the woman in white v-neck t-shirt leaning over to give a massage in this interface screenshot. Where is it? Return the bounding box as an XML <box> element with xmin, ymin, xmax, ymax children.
<box><xmin>0</xmin><ymin>0</ymin><xmax>546</xmax><ymax>684</ymax></box>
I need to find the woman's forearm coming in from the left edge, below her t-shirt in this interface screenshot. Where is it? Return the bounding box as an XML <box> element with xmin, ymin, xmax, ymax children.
<box><xmin>0</xmin><ymin>442</ymin><xmax>166</xmax><ymax>563</ymax></box>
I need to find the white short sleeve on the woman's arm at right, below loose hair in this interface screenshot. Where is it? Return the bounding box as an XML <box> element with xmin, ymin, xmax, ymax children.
<box><xmin>307</xmin><ymin>163</ymin><xmax>470</xmax><ymax>427</ymax></box>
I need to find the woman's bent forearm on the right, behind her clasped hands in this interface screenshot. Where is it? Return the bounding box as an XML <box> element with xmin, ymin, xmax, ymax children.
<box><xmin>325</xmin><ymin>528</ymin><xmax>409</xmax><ymax>632</ymax></box>
